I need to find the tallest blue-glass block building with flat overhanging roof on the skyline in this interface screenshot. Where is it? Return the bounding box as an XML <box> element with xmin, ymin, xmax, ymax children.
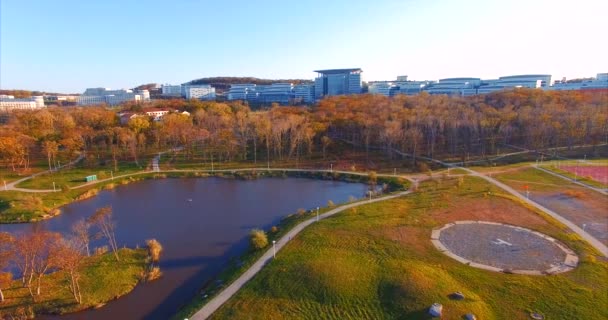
<box><xmin>315</xmin><ymin>68</ymin><xmax>363</xmax><ymax>99</ymax></box>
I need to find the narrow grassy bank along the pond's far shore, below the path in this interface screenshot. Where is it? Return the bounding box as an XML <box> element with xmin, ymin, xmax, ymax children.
<box><xmin>0</xmin><ymin>168</ymin><xmax>409</xmax><ymax>223</ymax></box>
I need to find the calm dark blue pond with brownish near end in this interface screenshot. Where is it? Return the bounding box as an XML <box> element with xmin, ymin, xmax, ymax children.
<box><xmin>0</xmin><ymin>178</ymin><xmax>366</xmax><ymax>320</ymax></box>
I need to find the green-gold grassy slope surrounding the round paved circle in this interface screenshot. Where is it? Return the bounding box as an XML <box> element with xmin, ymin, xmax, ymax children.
<box><xmin>214</xmin><ymin>178</ymin><xmax>608</xmax><ymax>319</ymax></box>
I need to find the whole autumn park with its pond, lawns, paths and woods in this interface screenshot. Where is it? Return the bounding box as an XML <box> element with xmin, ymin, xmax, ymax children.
<box><xmin>0</xmin><ymin>91</ymin><xmax>608</xmax><ymax>319</ymax></box>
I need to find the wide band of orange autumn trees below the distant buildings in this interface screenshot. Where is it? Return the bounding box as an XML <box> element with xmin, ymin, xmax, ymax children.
<box><xmin>0</xmin><ymin>89</ymin><xmax>608</xmax><ymax>170</ymax></box>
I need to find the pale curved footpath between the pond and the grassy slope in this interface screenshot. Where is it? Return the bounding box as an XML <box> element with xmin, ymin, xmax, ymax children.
<box><xmin>190</xmin><ymin>190</ymin><xmax>412</xmax><ymax>320</ymax></box>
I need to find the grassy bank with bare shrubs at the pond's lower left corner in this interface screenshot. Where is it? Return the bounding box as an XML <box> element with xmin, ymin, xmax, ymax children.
<box><xmin>0</xmin><ymin>249</ymin><xmax>147</xmax><ymax>318</ymax></box>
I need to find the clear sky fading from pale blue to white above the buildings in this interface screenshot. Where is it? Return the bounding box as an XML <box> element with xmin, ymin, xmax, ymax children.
<box><xmin>0</xmin><ymin>0</ymin><xmax>608</xmax><ymax>93</ymax></box>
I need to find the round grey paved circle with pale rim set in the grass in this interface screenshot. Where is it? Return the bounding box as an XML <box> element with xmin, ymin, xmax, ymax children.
<box><xmin>431</xmin><ymin>221</ymin><xmax>578</xmax><ymax>275</ymax></box>
